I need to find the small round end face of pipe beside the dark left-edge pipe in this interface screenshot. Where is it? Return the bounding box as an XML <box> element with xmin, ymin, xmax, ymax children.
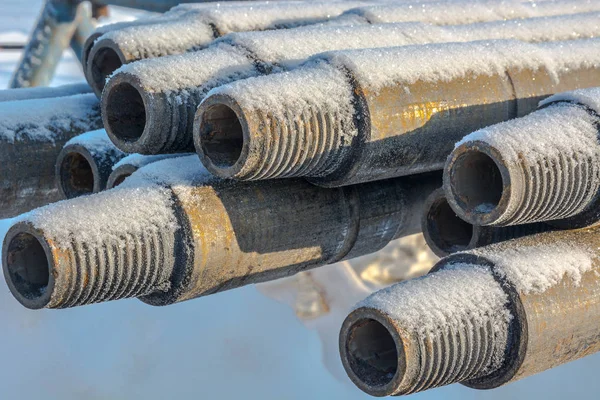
<box><xmin>56</xmin><ymin>144</ymin><xmax>100</xmax><ymax>199</ymax></box>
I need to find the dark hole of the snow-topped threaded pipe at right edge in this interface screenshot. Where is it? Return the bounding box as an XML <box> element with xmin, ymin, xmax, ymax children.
<box><xmin>450</xmin><ymin>150</ymin><xmax>504</xmax><ymax>214</ymax></box>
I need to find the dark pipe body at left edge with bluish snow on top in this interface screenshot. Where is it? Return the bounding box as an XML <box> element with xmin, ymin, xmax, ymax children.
<box><xmin>0</xmin><ymin>94</ymin><xmax>102</xmax><ymax>218</ymax></box>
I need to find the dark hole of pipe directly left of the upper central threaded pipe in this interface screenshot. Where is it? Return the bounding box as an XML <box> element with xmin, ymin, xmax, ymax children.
<box><xmin>106</xmin><ymin>82</ymin><xmax>146</xmax><ymax>142</ymax></box>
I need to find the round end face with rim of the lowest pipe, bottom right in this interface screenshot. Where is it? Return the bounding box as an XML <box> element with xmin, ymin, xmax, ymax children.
<box><xmin>340</xmin><ymin>308</ymin><xmax>406</xmax><ymax>397</ymax></box>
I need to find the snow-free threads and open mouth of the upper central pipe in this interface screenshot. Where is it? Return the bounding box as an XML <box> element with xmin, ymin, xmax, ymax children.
<box><xmin>194</xmin><ymin>94</ymin><xmax>349</xmax><ymax>180</ymax></box>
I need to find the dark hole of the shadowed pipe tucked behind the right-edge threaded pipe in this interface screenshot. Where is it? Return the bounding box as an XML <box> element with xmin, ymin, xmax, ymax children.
<box><xmin>426</xmin><ymin>197</ymin><xmax>473</xmax><ymax>253</ymax></box>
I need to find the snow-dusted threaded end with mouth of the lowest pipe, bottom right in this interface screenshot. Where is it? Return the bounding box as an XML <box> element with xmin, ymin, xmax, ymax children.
<box><xmin>340</xmin><ymin>266</ymin><xmax>510</xmax><ymax>396</ymax></box>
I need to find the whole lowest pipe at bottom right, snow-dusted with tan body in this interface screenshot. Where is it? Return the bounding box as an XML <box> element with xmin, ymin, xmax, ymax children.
<box><xmin>339</xmin><ymin>228</ymin><xmax>600</xmax><ymax>396</ymax></box>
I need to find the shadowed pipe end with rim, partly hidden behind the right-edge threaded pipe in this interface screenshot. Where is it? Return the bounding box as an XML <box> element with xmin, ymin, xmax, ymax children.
<box><xmin>421</xmin><ymin>188</ymin><xmax>475</xmax><ymax>257</ymax></box>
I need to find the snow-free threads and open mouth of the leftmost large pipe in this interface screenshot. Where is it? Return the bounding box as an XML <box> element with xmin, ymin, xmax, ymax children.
<box><xmin>2</xmin><ymin>222</ymin><xmax>174</xmax><ymax>309</ymax></box>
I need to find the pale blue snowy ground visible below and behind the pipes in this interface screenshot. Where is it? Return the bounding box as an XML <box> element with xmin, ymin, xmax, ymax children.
<box><xmin>0</xmin><ymin>0</ymin><xmax>600</xmax><ymax>400</ymax></box>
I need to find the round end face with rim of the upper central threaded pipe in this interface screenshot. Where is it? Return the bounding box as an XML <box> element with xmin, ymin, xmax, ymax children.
<box><xmin>194</xmin><ymin>95</ymin><xmax>249</xmax><ymax>178</ymax></box>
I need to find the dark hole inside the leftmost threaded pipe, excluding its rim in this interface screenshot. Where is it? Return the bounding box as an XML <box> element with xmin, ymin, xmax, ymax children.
<box><xmin>7</xmin><ymin>232</ymin><xmax>50</xmax><ymax>300</ymax></box>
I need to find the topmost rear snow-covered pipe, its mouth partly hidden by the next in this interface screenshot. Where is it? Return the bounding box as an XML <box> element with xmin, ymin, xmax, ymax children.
<box><xmin>85</xmin><ymin>1</ymin><xmax>364</xmax><ymax>97</ymax></box>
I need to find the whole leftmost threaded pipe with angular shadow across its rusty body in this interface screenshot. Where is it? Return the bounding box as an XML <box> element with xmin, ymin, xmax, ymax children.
<box><xmin>3</xmin><ymin>155</ymin><xmax>441</xmax><ymax>309</ymax></box>
